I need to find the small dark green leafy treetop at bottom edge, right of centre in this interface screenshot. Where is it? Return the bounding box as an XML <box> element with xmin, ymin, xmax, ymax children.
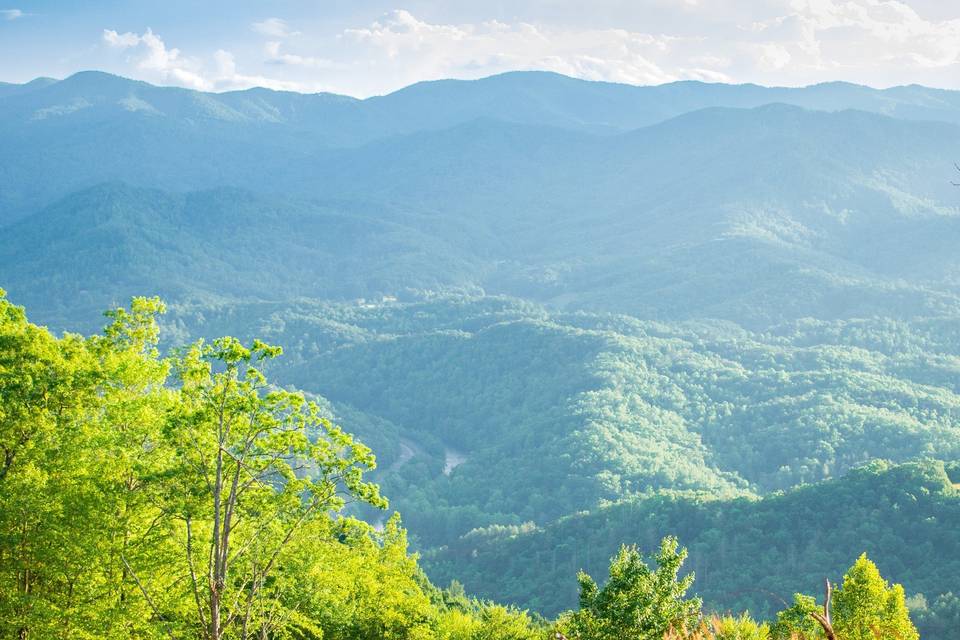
<box><xmin>560</xmin><ymin>537</ymin><xmax>701</xmax><ymax>640</ymax></box>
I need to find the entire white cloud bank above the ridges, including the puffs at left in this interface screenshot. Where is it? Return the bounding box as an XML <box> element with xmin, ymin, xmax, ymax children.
<box><xmin>94</xmin><ymin>0</ymin><xmax>960</xmax><ymax>96</ymax></box>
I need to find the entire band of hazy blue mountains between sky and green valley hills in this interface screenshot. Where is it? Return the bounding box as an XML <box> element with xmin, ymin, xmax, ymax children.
<box><xmin>0</xmin><ymin>72</ymin><xmax>960</xmax><ymax>326</ymax></box>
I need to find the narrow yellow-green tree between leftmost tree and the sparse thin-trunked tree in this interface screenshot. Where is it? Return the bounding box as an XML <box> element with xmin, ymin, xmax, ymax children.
<box><xmin>79</xmin><ymin>298</ymin><xmax>176</xmax><ymax>638</ymax></box>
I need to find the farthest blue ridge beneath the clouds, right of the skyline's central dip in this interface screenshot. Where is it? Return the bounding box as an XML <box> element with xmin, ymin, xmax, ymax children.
<box><xmin>365</xmin><ymin>71</ymin><xmax>960</xmax><ymax>133</ymax></box>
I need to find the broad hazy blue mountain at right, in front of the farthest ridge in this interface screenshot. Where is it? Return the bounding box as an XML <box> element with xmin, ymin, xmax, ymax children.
<box><xmin>316</xmin><ymin>105</ymin><xmax>960</xmax><ymax>322</ymax></box>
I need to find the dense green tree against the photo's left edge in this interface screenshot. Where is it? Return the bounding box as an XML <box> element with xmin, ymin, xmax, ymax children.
<box><xmin>0</xmin><ymin>290</ymin><xmax>97</xmax><ymax>639</ymax></box>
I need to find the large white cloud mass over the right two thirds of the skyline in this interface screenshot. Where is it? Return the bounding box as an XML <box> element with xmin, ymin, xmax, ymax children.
<box><xmin>324</xmin><ymin>0</ymin><xmax>960</xmax><ymax>92</ymax></box>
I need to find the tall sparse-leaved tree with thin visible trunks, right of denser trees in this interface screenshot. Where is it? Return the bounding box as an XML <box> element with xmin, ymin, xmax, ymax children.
<box><xmin>166</xmin><ymin>337</ymin><xmax>386</xmax><ymax>640</ymax></box>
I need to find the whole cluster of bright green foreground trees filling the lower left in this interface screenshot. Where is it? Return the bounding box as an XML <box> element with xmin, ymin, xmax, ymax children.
<box><xmin>0</xmin><ymin>292</ymin><xmax>552</xmax><ymax>640</ymax></box>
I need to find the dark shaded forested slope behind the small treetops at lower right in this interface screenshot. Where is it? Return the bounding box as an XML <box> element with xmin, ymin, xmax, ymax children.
<box><xmin>425</xmin><ymin>462</ymin><xmax>960</xmax><ymax>616</ymax></box>
